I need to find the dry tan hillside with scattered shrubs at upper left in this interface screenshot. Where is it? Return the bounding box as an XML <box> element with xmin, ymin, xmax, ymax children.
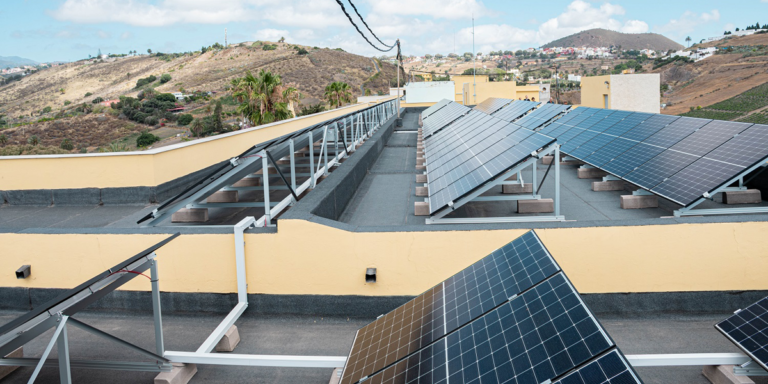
<box><xmin>0</xmin><ymin>43</ymin><xmax>404</xmax><ymax>119</ymax></box>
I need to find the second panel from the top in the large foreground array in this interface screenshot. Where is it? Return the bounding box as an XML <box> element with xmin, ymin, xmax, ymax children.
<box><xmin>360</xmin><ymin>273</ymin><xmax>614</xmax><ymax>384</ymax></box>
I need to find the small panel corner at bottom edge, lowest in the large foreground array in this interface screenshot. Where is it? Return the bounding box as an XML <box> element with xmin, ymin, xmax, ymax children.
<box><xmin>554</xmin><ymin>350</ymin><xmax>642</xmax><ymax>384</ymax></box>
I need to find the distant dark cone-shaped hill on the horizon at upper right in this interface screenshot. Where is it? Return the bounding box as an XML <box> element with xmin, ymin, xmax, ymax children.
<box><xmin>542</xmin><ymin>28</ymin><xmax>684</xmax><ymax>51</ymax></box>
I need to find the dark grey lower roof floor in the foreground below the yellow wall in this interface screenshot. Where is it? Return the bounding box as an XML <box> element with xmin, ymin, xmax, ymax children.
<box><xmin>0</xmin><ymin>308</ymin><xmax>768</xmax><ymax>384</ymax></box>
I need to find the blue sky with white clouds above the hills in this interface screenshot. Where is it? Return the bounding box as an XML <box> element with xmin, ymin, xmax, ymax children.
<box><xmin>0</xmin><ymin>0</ymin><xmax>768</xmax><ymax>62</ymax></box>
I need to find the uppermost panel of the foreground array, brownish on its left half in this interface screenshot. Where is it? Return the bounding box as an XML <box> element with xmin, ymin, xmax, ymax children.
<box><xmin>341</xmin><ymin>231</ymin><xmax>560</xmax><ymax>384</ymax></box>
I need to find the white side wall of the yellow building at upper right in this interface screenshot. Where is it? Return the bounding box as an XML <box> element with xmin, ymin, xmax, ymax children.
<box><xmin>610</xmin><ymin>73</ymin><xmax>661</xmax><ymax>113</ymax></box>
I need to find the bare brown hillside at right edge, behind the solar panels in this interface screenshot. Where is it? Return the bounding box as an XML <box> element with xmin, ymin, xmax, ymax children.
<box><xmin>653</xmin><ymin>34</ymin><xmax>768</xmax><ymax>115</ymax></box>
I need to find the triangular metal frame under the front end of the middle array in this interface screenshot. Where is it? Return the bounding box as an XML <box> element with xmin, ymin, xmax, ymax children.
<box><xmin>425</xmin><ymin>140</ymin><xmax>565</xmax><ymax>224</ymax></box>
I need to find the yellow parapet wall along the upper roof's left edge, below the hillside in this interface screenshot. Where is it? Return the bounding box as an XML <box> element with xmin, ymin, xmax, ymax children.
<box><xmin>0</xmin><ymin>96</ymin><xmax>394</xmax><ymax>190</ymax></box>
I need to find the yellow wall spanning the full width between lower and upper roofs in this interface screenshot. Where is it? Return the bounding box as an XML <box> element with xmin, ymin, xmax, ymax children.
<box><xmin>0</xmin><ymin>220</ymin><xmax>768</xmax><ymax>296</ymax></box>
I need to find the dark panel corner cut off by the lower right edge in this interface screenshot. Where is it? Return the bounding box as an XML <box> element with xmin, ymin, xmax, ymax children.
<box><xmin>715</xmin><ymin>297</ymin><xmax>768</xmax><ymax>370</ymax></box>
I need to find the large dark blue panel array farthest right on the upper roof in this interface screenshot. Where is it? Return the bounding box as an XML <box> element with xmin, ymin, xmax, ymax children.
<box><xmin>539</xmin><ymin>108</ymin><xmax>768</xmax><ymax>206</ymax></box>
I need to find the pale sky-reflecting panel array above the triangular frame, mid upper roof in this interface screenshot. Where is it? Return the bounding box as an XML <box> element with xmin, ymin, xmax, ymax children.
<box><xmin>424</xmin><ymin>106</ymin><xmax>554</xmax><ymax>213</ymax></box>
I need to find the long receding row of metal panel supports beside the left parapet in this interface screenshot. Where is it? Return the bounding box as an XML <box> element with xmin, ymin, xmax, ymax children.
<box><xmin>137</xmin><ymin>101</ymin><xmax>396</xmax><ymax>227</ymax></box>
